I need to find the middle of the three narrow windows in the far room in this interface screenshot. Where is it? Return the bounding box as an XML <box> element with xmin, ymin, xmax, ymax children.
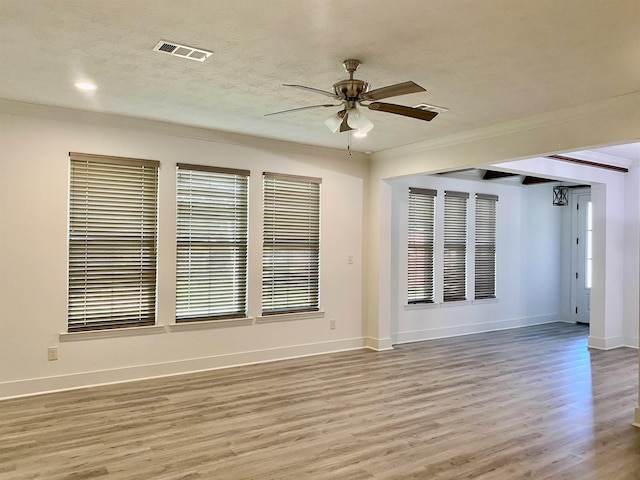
<box><xmin>443</xmin><ymin>191</ymin><xmax>469</xmax><ymax>302</ymax></box>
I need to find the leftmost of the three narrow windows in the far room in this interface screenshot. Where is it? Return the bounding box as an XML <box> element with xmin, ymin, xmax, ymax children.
<box><xmin>407</xmin><ymin>188</ymin><xmax>436</xmax><ymax>303</ymax></box>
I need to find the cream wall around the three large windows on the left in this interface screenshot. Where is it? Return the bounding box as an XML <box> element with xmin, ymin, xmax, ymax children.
<box><xmin>0</xmin><ymin>102</ymin><xmax>368</xmax><ymax>397</ymax></box>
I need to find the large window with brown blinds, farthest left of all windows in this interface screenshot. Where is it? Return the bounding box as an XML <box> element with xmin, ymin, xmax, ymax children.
<box><xmin>68</xmin><ymin>153</ymin><xmax>160</xmax><ymax>332</ymax></box>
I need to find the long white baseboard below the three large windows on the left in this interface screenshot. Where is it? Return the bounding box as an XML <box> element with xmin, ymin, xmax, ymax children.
<box><xmin>0</xmin><ymin>337</ymin><xmax>364</xmax><ymax>399</ymax></box>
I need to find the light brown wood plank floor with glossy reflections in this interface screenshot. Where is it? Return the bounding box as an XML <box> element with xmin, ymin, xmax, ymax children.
<box><xmin>0</xmin><ymin>324</ymin><xmax>640</xmax><ymax>480</ymax></box>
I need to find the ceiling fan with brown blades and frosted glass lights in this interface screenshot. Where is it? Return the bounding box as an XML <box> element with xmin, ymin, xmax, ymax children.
<box><xmin>265</xmin><ymin>59</ymin><xmax>438</xmax><ymax>137</ymax></box>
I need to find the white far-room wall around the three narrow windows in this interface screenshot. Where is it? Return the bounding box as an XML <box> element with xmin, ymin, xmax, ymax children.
<box><xmin>389</xmin><ymin>175</ymin><xmax>561</xmax><ymax>343</ymax></box>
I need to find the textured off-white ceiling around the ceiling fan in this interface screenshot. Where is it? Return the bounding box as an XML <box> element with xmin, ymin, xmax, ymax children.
<box><xmin>0</xmin><ymin>0</ymin><xmax>640</xmax><ymax>151</ymax></box>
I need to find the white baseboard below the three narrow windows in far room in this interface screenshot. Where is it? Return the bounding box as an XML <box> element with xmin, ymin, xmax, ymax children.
<box><xmin>393</xmin><ymin>314</ymin><xmax>558</xmax><ymax>344</ymax></box>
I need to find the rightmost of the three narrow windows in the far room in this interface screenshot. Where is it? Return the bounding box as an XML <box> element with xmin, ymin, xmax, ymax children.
<box><xmin>475</xmin><ymin>193</ymin><xmax>498</xmax><ymax>299</ymax></box>
